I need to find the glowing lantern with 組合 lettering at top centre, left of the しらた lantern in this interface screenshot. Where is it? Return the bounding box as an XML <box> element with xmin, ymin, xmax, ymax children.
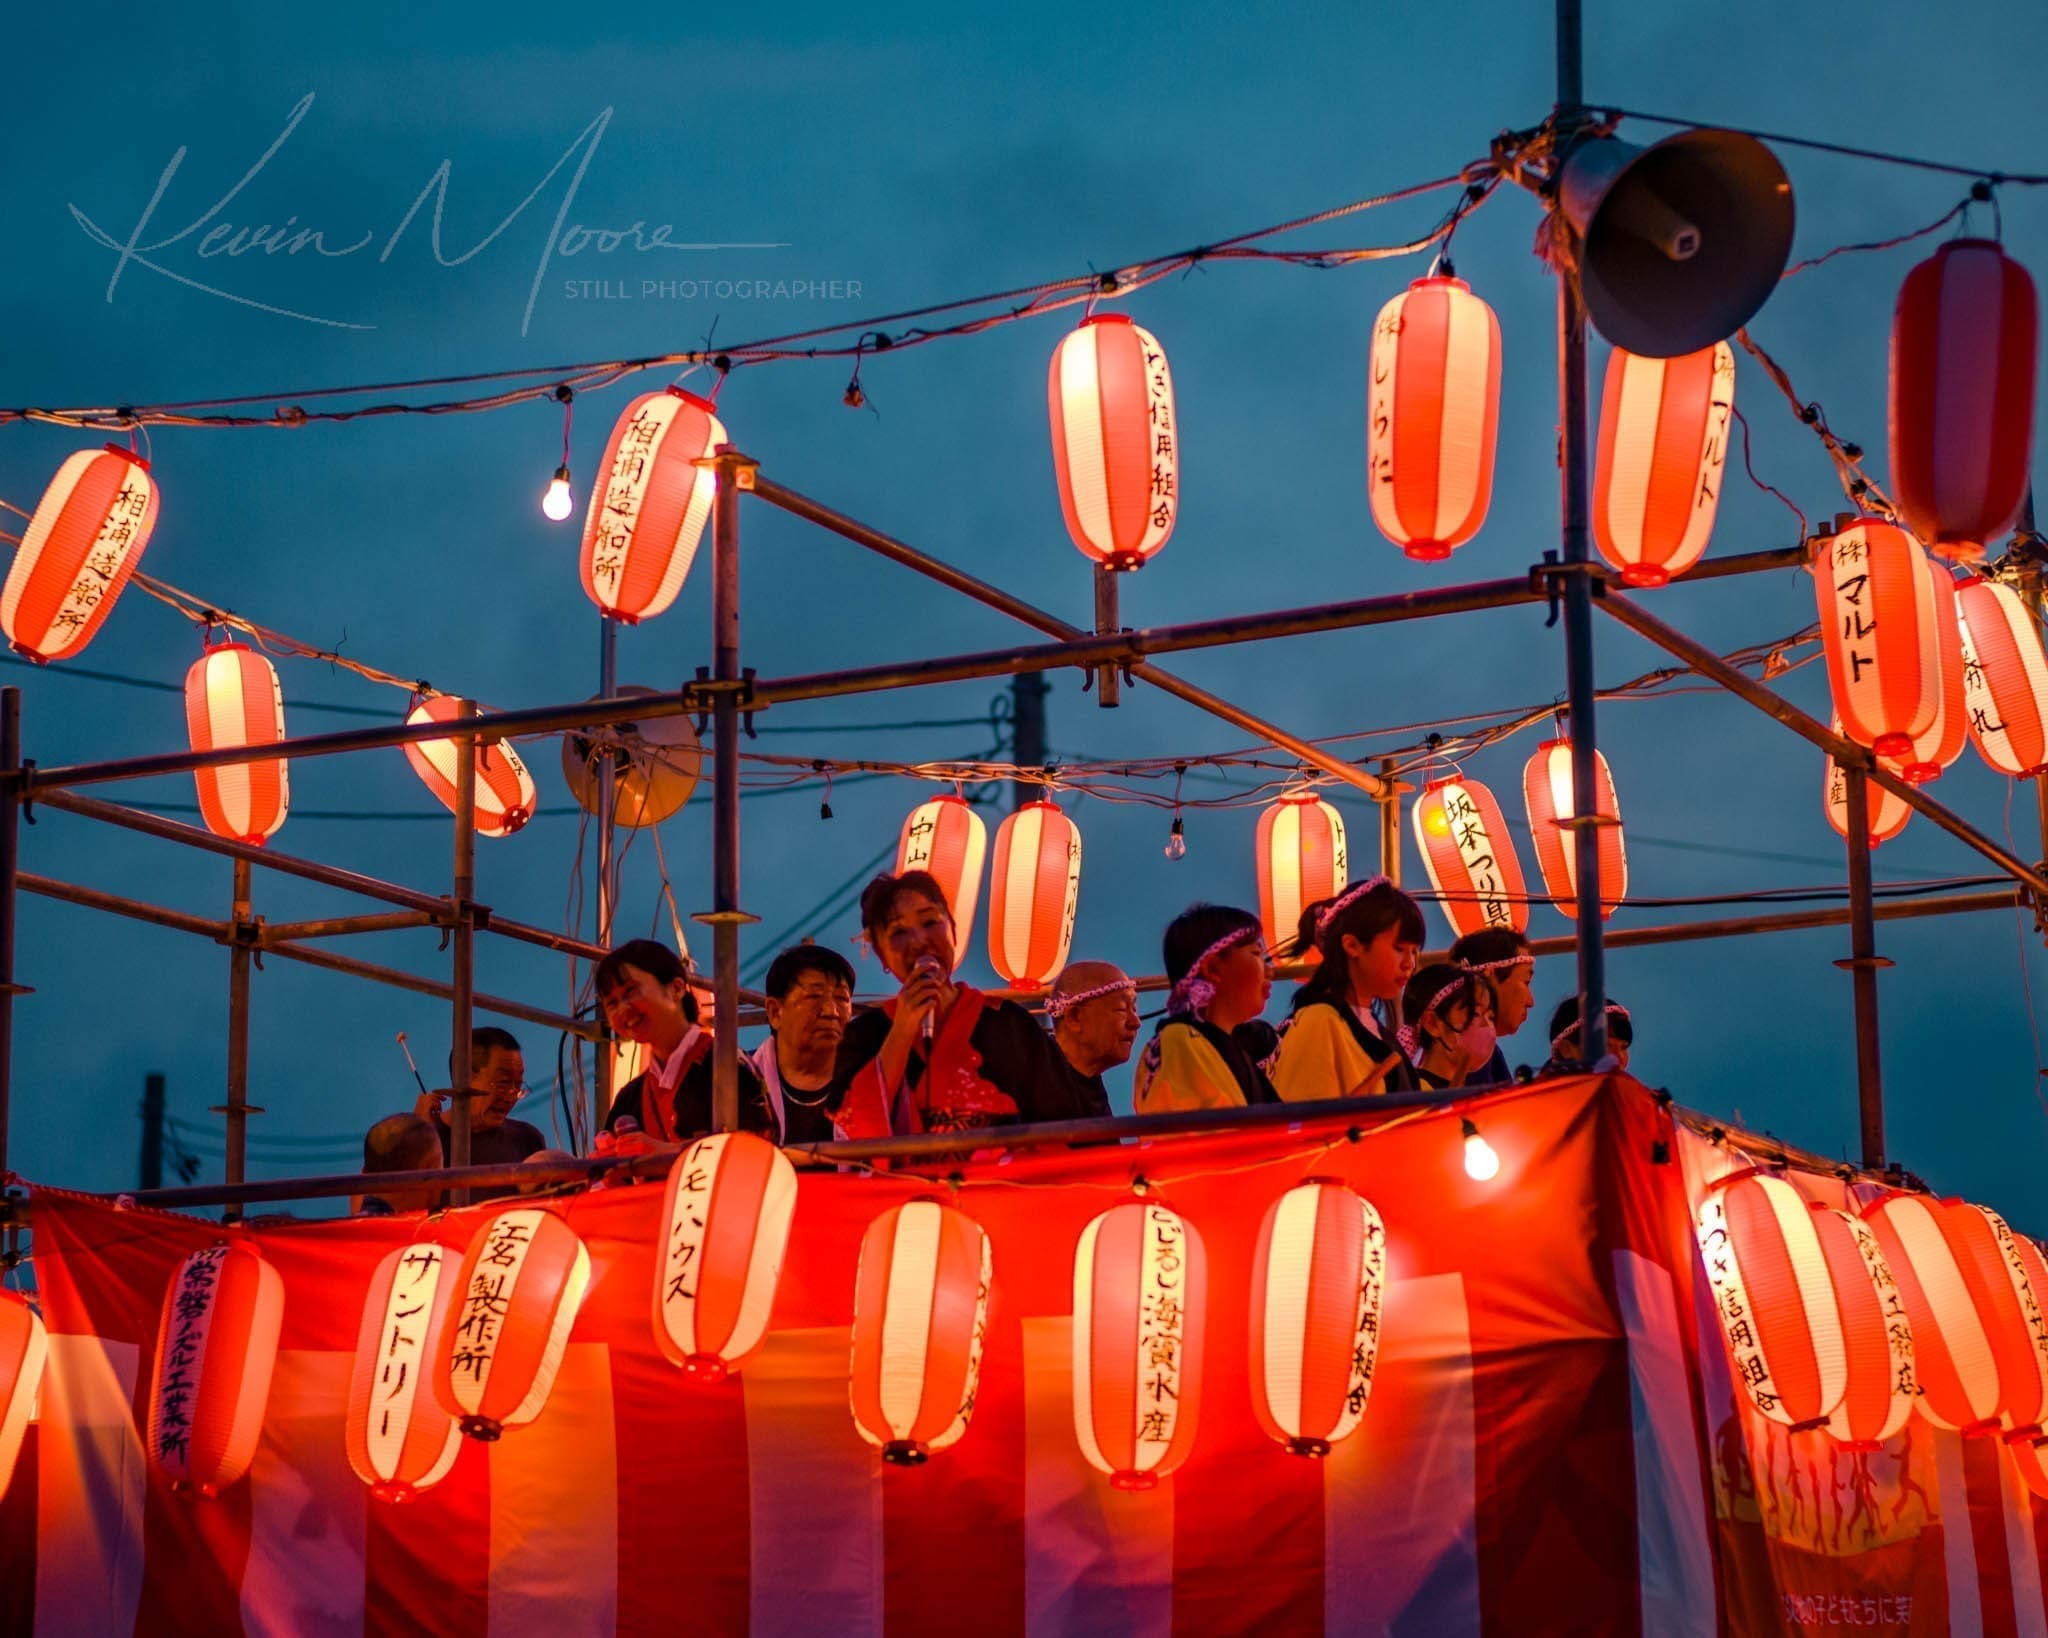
<box><xmin>1047</xmin><ymin>313</ymin><xmax>1180</xmax><ymax>569</ymax></box>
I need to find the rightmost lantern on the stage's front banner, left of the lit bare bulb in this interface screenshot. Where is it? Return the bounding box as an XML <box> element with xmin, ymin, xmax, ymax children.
<box><xmin>1251</xmin><ymin>1177</ymin><xmax>1386</xmax><ymax>1456</ymax></box>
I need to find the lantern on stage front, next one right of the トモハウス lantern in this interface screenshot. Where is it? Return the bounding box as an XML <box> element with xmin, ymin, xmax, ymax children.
<box><xmin>852</xmin><ymin>1200</ymin><xmax>993</xmax><ymax>1466</ymax></box>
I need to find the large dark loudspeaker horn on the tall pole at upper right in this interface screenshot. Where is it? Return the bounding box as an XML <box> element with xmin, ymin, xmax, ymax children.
<box><xmin>1559</xmin><ymin>129</ymin><xmax>1792</xmax><ymax>358</ymax></box>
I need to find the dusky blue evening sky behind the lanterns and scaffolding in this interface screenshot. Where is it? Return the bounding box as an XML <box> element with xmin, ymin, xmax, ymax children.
<box><xmin>0</xmin><ymin>0</ymin><xmax>2048</xmax><ymax>1231</ymax></box>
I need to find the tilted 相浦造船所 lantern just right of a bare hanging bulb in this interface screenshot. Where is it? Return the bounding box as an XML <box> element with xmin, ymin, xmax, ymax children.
<box><xmin>582</xmin><ymin>387</ymin><xmax>725</xmax><ymax>624</ymax></box>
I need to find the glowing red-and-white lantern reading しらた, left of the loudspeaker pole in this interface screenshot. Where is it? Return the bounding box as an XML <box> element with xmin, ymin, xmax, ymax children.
<box><xmin>1366</xmin><ymin>274</ymin><xmax>1501</xmax><ymax>561</ymax></box>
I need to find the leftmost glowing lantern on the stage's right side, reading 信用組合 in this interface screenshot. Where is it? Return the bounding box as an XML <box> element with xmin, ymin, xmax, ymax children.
<box><xmin>1700</xmin><ymin>1173</ymin><xmax>1849</xmax><ymax>1427</ymax></box>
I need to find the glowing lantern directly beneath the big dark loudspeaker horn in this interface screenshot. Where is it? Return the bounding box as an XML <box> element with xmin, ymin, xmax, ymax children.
<box><xmin>1593</xmin><ymin>342</ymin><xmax>1735</xmax><ymax>586</ymax></box>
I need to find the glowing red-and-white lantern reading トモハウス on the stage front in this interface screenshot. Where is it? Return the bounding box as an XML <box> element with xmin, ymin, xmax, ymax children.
<box><xmin>653</xmin><ymin>1132</ymin><xmax>797</xmax><ymax>1382</ymax></box>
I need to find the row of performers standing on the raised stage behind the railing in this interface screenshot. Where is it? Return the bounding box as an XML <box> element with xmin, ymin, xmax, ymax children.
<box><xmin>362</xmin><ymin>870</ymin><xmax>1634</xmax><ymax>1210</ymax></box>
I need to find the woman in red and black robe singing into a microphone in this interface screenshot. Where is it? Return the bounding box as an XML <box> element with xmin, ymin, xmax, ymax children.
<box><xmin>827</xmin><ymin>870</ymin><xmax>1087</xmax><ymax>1138</ymax></box>
